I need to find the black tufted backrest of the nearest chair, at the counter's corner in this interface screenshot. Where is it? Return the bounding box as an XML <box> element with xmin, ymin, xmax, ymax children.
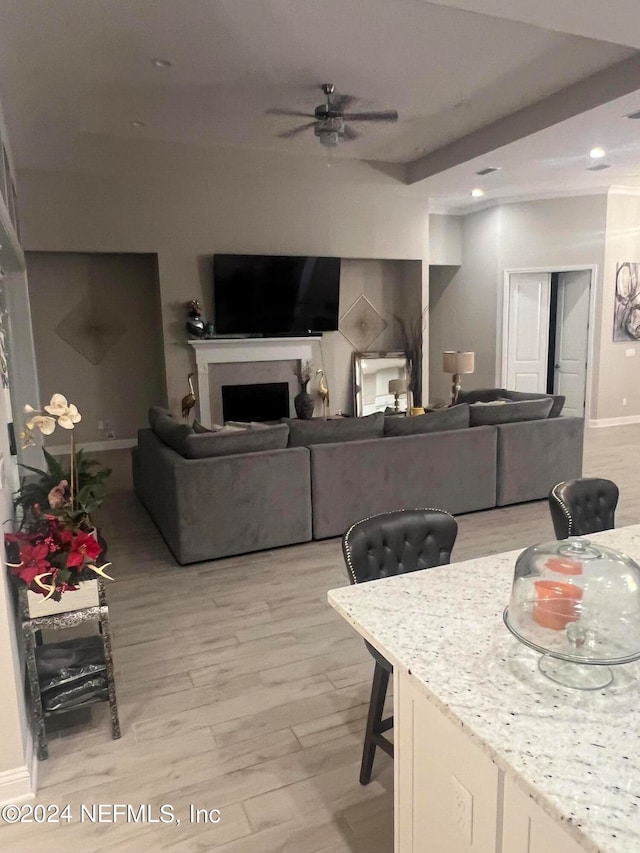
<box><xmin>342</xmin><ymin>509</ymin><xmax>458</xmax><ymax>584</ymax></box>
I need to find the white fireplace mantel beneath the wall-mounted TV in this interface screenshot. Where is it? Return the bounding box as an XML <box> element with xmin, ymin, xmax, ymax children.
<box><xmin>189</xmin><ymin>335</ymin><xmax>322</xmax><ymax>427</ymax></box>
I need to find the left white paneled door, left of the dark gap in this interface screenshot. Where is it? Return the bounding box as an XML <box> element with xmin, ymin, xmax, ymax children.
<box><xmin>507</xmin><ymin>273</ymin><xmax>551</xmax><ymax>392</ymax></box>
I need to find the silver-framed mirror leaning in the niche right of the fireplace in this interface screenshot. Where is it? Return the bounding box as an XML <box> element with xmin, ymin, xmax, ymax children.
<box><xmin>353</xmin><ymin>352</ymin><xmax>410</xmax><ymax>418</ymax></box>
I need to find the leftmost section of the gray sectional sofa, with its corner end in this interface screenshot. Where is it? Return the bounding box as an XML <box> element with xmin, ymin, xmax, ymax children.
<box><xmin>134</xmin><ymin>430</ymin><xmax>311</xmax><ymax>563</ymax></box>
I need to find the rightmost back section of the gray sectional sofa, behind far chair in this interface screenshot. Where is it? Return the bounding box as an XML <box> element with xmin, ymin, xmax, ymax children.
<box><xmin>496</xmin><ymin>416</ymin><xmax>584</xmax><ymax>506</ymax></box>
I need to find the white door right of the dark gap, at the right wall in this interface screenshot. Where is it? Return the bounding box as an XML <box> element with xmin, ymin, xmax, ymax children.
<box><xmin>554</xmin><ymin>270</ymin><xmax>591</xmax><ymax>417</ymax></box>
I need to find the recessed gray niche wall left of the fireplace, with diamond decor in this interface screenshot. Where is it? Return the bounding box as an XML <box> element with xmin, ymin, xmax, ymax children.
<box><xmin>27</xmin><ymin>252</ymin><xmax>166</xmax><ymax>446</ymax></box>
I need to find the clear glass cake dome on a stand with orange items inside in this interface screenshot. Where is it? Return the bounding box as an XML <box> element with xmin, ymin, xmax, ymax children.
<box><xmin>504</xmin><ymin>537</ymin><xmax>640</xmax><ymax>690</ymax></box>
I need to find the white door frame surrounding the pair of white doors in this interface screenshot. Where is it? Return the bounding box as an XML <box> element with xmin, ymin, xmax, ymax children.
<box><xmin>496</xmin><ymin>264</ymin><xmax>598</xmax><ymax>425</ymax></box>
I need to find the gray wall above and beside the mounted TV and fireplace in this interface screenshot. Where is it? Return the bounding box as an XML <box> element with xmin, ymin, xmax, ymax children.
<box><xmin>20</xmin><ymin>140</ymin><xmax>429</xmax><ymax>420</ymax></box>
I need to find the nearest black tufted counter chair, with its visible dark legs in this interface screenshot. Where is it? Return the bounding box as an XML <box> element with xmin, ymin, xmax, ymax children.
<box><xmin>342</xmin><ymin>509</ymin><xmax>458</xmax><ymax>785</ymax></box>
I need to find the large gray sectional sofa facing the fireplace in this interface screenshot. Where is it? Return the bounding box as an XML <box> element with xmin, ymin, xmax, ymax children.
<box><xmin>132</xmin><ymin>398</ymin><xmax>584</xmax><ymax>564</ymax></box>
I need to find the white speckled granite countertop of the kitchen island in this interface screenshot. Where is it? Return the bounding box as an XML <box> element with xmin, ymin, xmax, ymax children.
<box><xmin>329</xmin><ymin>524</ymin><xmax>640</xmax><ymax>853</ymax></box>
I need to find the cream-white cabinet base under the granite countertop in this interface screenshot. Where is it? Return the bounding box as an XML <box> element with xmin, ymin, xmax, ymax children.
<box><xmin>394</xmin><ymin>670</ymin><xmax>584</xmax><ymax>853</ymax></box>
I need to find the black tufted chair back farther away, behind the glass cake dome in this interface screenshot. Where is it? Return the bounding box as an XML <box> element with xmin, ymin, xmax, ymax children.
<box><xmin>549</xmin><ymin>477</ymin><xmax>619</xmax><ymax>539</ymax></box>
